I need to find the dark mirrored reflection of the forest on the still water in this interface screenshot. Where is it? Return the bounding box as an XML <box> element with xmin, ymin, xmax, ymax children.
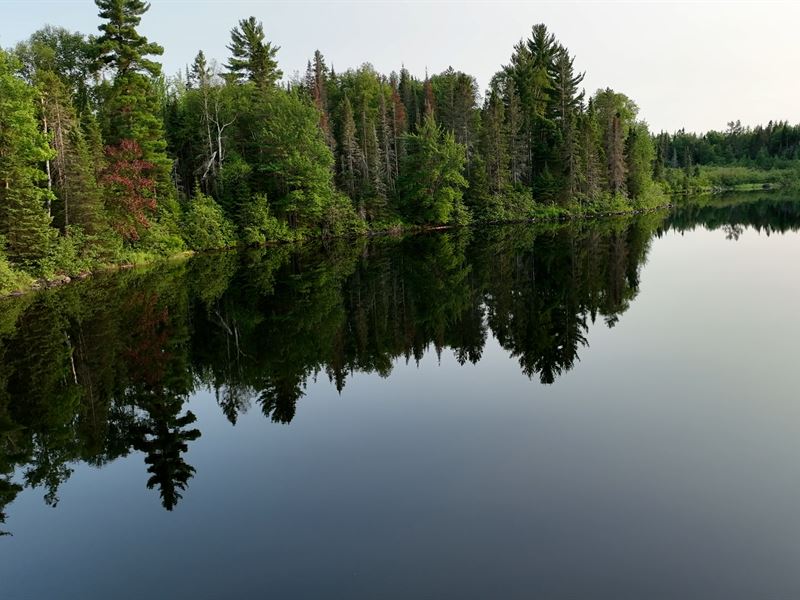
<box><xmin>0</xmin><ymin>199</ymin><xmax>800</xmax><ymax>529</ymax></box>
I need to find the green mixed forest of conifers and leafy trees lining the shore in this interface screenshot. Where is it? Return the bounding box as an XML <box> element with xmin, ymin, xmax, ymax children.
<box><xmin>0</xmin><ymin>0</ymin><xmax>800</xmax><ymax>296</ymax></box>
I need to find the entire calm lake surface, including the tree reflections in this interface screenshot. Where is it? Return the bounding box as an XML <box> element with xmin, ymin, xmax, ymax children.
<box><xmin>0</xmin><ymin>196</ymin><xmax>800</xmax><ymax>599</ymax></box>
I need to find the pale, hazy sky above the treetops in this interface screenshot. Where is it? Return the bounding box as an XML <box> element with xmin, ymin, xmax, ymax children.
<box><xmin>0</xmin><ymin>0</ymin><xmax>800</xmax><ymax>132</ymax></box>
